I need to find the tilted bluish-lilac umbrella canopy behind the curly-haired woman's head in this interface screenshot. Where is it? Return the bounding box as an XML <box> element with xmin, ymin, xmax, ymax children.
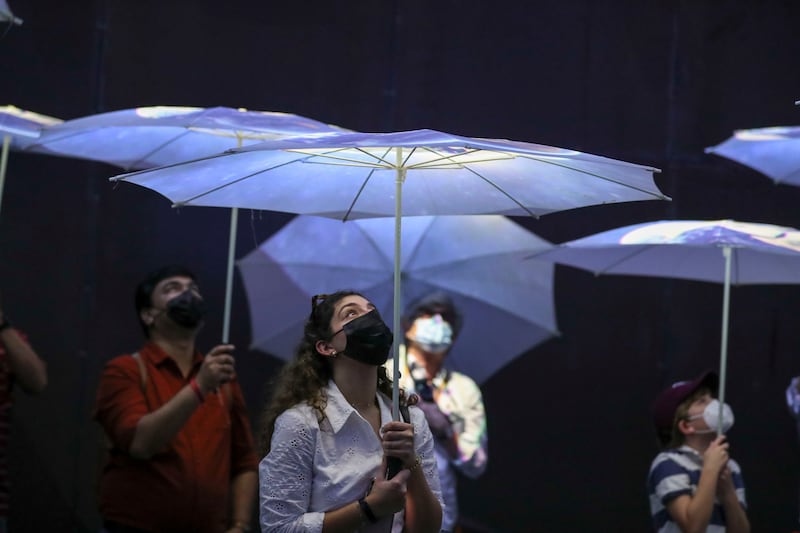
<box><xmin>237</xmin><ymin>215</ymin><xmax>557</xmax><ymax>383</ymax></box>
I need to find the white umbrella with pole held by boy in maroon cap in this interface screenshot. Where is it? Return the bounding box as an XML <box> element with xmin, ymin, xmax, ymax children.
<box><xmin>532</xmin><ymin>220</ymin><xmax>800</xmax><ymax>430</ymax></box>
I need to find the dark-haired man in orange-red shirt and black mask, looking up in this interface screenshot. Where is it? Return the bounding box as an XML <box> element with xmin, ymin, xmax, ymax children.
<box><xmin>95</xmin><ymin>266</ymin><xmax>258</xmax><ymax>533</ymax></box>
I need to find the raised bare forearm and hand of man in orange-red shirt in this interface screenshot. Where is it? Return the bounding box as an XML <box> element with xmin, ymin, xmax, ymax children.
<box><xmin>128</xmin><ymin>344</ymin><xmax>233</xmax><ymax>459</ymax></box>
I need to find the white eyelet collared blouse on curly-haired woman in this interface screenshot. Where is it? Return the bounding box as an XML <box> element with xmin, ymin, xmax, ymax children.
<box><xmin>258</xmin><ymin>380</ymin><xmax>444</xmax><ymax>533</ymax></box>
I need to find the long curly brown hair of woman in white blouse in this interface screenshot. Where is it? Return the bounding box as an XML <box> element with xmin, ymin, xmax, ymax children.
<box><xmin>258</xmin><ymin>290</ymin><xmax>414</xmax><ymax>457</ymax></box>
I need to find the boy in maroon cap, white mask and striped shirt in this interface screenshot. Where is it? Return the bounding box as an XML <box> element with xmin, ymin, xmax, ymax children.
<box><xmin>647</xmin><ymin>371</ymin><xmax>750</xmax><ymax>533</ymax></box>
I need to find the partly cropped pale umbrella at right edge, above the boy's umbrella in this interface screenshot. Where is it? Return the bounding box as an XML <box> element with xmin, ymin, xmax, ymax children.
<box><xmin>706</xmin><ymin>126</ymin><xmax>800</xmax><ymax>186</ymax></box>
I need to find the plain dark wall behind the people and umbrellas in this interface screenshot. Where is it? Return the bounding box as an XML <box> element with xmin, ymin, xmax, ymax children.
<box><xmin>0</xmin><ymin>0</ymin><xmax>800</xmax><ymax>532</ymax></box>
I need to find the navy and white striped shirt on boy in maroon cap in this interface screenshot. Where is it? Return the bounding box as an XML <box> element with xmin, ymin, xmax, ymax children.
<box><xmin>647</xmin><ymin>445</ymin><xmax>747</xmax><ymax>533</ymax></box>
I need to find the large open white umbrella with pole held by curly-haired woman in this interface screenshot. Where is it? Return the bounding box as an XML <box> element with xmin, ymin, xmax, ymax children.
<box><xmin>111</xmin><ymin>125</ymin><xmax>668</xmax><ymax>419</ymax></box>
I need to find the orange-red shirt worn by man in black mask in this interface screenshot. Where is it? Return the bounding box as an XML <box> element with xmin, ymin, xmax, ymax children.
<box><xmin>94</xmin><ymin>342</ymin><xmax>258</xmax><ymax>533</ymax></box>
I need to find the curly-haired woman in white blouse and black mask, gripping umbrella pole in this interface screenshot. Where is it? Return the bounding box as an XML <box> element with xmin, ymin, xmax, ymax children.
<box><xmin>259</xmin><ymin>291</ymin><xmax>442</xmax><ymax>533</ymax></box>
